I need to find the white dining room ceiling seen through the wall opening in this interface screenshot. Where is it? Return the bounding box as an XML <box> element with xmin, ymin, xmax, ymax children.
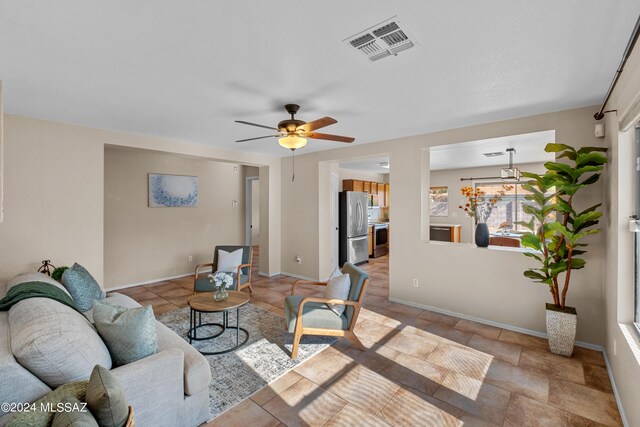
<box><xmin>429</xmin><ymin>130</ymin><xmax>556</xmax><ymax>170</ymax></box>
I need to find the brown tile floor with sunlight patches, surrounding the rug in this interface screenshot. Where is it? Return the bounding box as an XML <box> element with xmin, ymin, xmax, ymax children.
<box><xmin>114</xmin><ymin>251</ymin><xmax>622</xmax><ymax>427</ymax></box>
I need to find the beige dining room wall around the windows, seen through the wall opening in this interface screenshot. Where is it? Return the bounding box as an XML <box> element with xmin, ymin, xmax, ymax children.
<box><xmin>425</xmin><ymin>163</ymin><xmax>544</xmax><ymax>243</ymax></box>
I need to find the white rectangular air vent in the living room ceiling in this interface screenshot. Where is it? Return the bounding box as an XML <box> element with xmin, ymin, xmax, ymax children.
<box><xmin>343</xmin><ymin>16</ymin><xmax>418</xmax><ymax>61</ymax></box>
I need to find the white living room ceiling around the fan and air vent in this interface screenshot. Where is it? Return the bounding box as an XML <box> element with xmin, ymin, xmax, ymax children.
<box><xmin>0</xmin><ymin>0</ymin><xmax>640</xmax><ymax>156</ymax></box>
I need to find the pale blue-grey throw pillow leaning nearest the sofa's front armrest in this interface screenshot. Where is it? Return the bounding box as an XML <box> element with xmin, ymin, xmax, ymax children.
<box><xmin>93</xmin><ymin>301</ymin><xmax>158</xmax><ymax>366</ymax></box>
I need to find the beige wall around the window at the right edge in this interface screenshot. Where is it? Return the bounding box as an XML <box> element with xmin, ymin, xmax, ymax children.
<box><xmin>604</xmin><ymin>38</ymin><xmax>640</xmax><ymax>426</ymax></box>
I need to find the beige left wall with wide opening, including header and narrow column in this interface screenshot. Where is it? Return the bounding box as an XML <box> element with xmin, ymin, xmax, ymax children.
<box><xmin>0</xmin><ymin>114</ymin><xmax>281</xmax><ymax>284</ymax></box>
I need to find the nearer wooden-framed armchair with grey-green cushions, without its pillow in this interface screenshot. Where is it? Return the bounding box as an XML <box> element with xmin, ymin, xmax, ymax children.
<box><xmin>284</xmin><ymin>262</ymin><xmax>369</xmax><ymax>359</ymax></box>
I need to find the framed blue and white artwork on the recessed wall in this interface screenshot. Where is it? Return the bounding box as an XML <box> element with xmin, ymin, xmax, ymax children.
<box><xmin>149</xmin><ymin>173</ymin><xmax>198</xmax><ymax>208</ymax></box>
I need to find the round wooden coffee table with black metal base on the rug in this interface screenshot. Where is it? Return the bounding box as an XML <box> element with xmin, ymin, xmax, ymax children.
<box><xmin>187</xmin><ymin>291</ymin><xmax>249</xmax><ymax>355</ymax></box>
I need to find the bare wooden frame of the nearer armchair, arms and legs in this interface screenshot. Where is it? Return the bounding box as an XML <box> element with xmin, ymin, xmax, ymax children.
<box><xmin>291</xmin><ymin>279</ymin><xmax>369</xmax><ymax>359</ymax></box>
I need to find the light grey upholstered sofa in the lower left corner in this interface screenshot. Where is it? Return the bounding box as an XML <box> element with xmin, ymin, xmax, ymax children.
<box><xmin>0</xmin><ymin>273</ymin><xmax>211</xmax><ymax>427</ymax></box>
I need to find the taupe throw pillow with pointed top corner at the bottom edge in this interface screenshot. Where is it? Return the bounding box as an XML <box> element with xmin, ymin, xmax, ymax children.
<box><xmin>87</xmin><ymin>365</ymin><xmax>129</xmax><ymax>427</ymax></box>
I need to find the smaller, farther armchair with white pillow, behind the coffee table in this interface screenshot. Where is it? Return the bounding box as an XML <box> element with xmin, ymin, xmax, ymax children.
<box><xmin>193</xmin><ymin>245</ymin><xmax>253</xmax><ymax>293</ymax></box>
